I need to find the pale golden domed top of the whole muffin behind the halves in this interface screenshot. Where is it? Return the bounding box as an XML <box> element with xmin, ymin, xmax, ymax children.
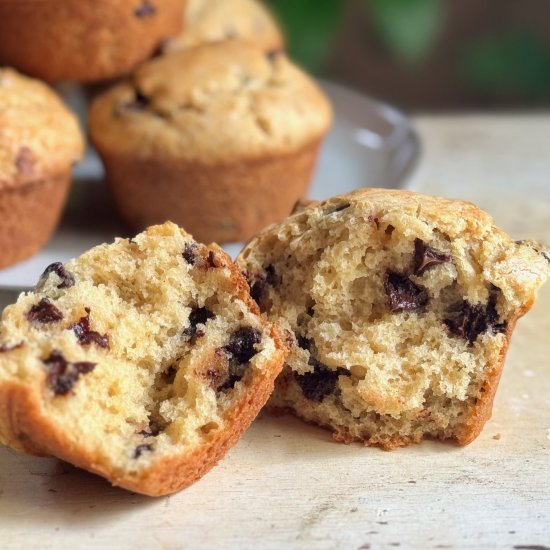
<box><xmin>90</xmin><ymin>40</ymin><xmax>332</xmax><ymax>164</ymax></box>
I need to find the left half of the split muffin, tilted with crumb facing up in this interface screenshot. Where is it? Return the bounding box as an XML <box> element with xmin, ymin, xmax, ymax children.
<box><xmin>0</xmin><ymin>223</ymin><xmax>286</xmax><ymax>496</ymax></box>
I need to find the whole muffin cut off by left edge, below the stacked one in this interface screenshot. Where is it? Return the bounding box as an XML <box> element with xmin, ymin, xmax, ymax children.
<box><xmin>0</xmin><ymin>68</ymin><xmax>84</xmax><ymax>268</ymax></box>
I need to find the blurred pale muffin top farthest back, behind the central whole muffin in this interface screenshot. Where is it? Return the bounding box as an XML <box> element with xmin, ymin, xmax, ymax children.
<box><xmin>164</xmin><ymin>0</ymin><xmax>284</xmax><ymax>53</ymax></box>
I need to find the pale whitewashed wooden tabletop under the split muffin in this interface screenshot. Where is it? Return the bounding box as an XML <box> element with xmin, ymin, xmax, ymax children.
<box><xmin>0</xmin><ymin>115</ymin><xmax>550</xmax><ymax>549</ymax></box>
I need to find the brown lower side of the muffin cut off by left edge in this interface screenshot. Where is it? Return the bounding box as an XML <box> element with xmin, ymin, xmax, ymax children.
<box><xmin>0</xmin><ymin>170</ymin><xmax>71</xmax><ymax>268</ymax></box>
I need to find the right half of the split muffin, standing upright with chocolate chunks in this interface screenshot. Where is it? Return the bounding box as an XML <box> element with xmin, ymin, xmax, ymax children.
<box><xmin>237</xmin><ymin>189</ymin><xmax>550</xmax><ymax>449</ymax></box>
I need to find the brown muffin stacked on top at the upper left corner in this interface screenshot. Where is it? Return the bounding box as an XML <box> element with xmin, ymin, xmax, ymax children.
<box><xmin>0</xmin><ymin>0</ymin><xmax>185</xmax><ymax>82</ymax></box>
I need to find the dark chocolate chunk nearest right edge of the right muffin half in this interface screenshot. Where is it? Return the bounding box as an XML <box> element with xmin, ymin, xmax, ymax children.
<box><xmin>443</xmin><ymin>287</ymin><xmax>507</xmax><ymax>344</ymax></box>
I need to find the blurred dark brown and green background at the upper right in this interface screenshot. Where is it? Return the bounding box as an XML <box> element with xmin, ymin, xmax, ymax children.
<box><xmin>268</xmin><ymin>0</ymin><xmax>550</xmax><ymax>111</ymax></box>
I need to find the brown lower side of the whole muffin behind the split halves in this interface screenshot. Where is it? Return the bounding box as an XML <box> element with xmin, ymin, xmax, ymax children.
<box><xmin>102</xmin><ymin>142</ymin><xmax>319</xmax><ymax>243</ymax></box>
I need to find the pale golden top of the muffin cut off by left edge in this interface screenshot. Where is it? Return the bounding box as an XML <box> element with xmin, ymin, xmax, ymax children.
<box><xmin>0</xmin><ymin>68</ymin><xmax>84</xmax><ymax>189</ymax></box>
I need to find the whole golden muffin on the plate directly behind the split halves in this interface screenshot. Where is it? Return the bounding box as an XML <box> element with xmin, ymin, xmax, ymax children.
<box><xmin>90</xmin><ymin>40</ymin><xmax>331</xmax><ymax>242</ymax></box>
